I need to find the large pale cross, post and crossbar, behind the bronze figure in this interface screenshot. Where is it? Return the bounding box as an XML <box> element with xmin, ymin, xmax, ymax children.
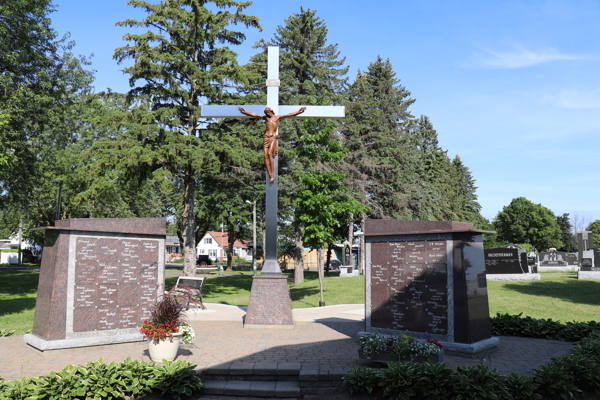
<box><xmin>201</xmin><ymin>46</ymin><xmax>344</xmax><ymax>275</ymax></box>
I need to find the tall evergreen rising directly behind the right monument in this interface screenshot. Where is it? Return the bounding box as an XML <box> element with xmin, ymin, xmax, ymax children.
<box><xmin>341</xmin><ymin>57</ymin><xmax>423</xmax><ymax>219</ymax></box>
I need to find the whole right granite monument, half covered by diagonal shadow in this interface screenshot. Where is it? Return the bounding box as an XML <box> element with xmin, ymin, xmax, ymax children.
<box><xmin>365</xmin><ymin>220</ymin><xmax>498</xmax><ymax>354</ymax></box>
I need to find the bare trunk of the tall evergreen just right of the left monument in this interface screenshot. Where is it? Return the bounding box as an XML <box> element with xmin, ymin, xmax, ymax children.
<box><xmin>183</xmin><ymin>164</ymin><xmax>196</xmax><ymax>276</ymax></box>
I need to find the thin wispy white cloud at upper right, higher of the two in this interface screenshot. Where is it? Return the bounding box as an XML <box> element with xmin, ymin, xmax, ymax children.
<box><xmin>470</xmin><ymin>46</ymin><xmax>587</xmax><ymax>69</ymax></box>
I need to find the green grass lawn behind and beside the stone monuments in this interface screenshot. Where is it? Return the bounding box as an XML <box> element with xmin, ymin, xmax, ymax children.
<box><xmin>0</xmin><ymin>270</ymin><xmax>600</xmax><ymax>335</ymax></box>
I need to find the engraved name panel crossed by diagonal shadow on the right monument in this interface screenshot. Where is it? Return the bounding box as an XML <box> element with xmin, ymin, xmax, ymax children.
<box><xmin>371</xmin><ymin>241</ymin><xmax>448</xmax><ymax>335</ymax></box>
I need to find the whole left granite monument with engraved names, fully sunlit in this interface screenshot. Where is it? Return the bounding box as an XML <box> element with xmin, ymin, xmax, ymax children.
<box><xmin>24</xmin><ymin>218</ymin><xmax>166</xmax><ymax>350</ymax></box>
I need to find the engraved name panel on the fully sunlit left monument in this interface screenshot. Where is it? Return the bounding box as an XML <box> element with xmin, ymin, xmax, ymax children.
<box><xmin>73</xmin><ymin>237</ymin><xmax>159</xmax><ymax>332</ymax></box>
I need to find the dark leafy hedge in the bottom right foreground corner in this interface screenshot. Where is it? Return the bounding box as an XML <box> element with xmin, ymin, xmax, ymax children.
<box><xmin>344</xmin><ymin>332</ymin><xmax>600</xmax><ymax>400</ymax></box>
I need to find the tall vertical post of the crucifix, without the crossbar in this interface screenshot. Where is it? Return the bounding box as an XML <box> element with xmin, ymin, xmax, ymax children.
<box><xmin>261</xmin><ymin>46</ymin><xmax>281</xmax><ymax>275</ymax></box>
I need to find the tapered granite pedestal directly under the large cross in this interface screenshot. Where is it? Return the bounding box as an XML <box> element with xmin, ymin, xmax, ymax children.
<box><xmin>244</xmin><ymin>275</ymin><xmax>294</xmax><ymax>329</ymax></box>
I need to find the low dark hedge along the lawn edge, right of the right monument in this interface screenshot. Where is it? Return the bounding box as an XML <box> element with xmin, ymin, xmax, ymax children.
<box><xmin>490</xmin><ymin>313</ymin><xmax>600</xmax><ymax>342</ymax></box>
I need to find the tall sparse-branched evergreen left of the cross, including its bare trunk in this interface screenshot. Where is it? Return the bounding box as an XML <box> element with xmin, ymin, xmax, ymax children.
<box><xmin>114</xmin><ymin>0</ymin><xmax>260</xmax><ymax>275</ymax></box>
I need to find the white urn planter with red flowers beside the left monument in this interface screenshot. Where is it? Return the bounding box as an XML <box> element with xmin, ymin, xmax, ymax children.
<box><xmin>140</xmin><ymin>285</ymin><xmax>200</xmax><ymax>361</ymax></box>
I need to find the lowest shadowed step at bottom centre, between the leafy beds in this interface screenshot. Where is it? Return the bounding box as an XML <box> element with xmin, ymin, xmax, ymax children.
<box><xmin>202</xmin><ymin>380</ymin><xmax>301</xmax><ymax>399</ymax></box>
